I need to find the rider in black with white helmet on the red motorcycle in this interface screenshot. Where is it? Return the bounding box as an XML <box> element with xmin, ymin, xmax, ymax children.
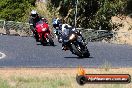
<box><xmin>29</xmin><ymin>10</ymin><xmax>47</xmax><ymax>42</ymax></box>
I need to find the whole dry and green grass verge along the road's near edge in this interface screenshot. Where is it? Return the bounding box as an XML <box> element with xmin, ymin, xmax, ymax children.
<box><xmin>0</xmin><ymin>68</ymin><xmax>132</xmax><ymax>88</ymax></box>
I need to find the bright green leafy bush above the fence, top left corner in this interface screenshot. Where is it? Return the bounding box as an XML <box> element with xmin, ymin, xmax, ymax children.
<box><xmin>0</xmin><ymin>0</ymin><xmax>35</xmax><ymax>21</ymax></box>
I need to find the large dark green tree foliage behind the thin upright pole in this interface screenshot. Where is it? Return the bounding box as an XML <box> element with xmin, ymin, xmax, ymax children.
<box><xmin>49</xmin><ymin>0</ymin><xmax>131</xmax><ymax>30</ymax></box>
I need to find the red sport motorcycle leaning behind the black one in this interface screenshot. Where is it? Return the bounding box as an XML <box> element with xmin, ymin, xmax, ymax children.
<box><xmin>36</xmin><ymin>21</ymin><xmax>54</xmax><ymax>46</ymax></box>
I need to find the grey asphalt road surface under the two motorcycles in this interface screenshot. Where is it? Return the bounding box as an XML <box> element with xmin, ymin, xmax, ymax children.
<box><xmin>0</xmin><ymin>35</ymin><xmax>132</xmax><ymax>68</ymax></box>
